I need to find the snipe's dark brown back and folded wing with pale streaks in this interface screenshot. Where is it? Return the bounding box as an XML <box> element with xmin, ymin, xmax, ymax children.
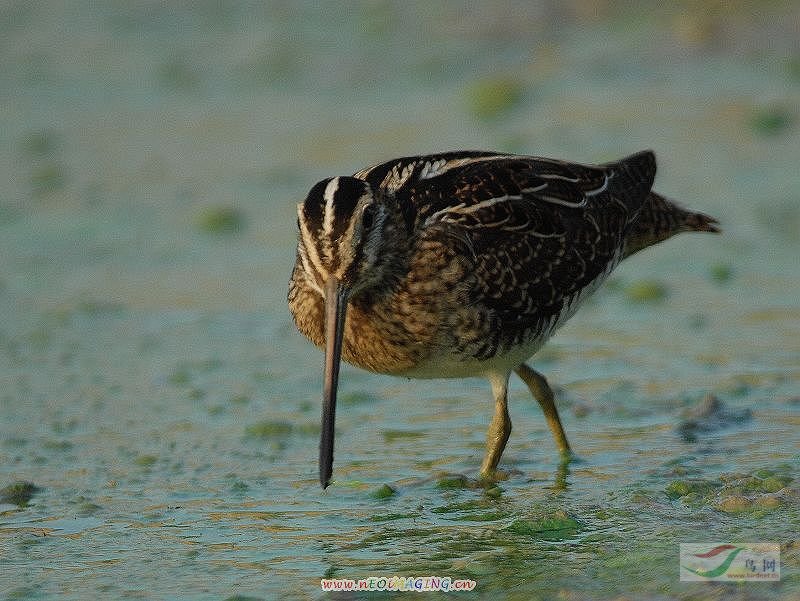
<box><xmin>358</xmin><ymin>151</ymin><xmax>655</xmax><ymax>361</ymax></box>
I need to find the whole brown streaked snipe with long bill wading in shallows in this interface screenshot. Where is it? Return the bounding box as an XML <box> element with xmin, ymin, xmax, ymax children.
<box><xmin>289</xmin><ymin>151</ymin><xmax>718</xmax><ymax>487</ymax></box>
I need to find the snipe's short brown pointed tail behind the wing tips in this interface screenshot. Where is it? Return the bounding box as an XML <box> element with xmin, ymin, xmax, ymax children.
<box><xmin>623</xmin><ymin>192</ymin><xmax>721</xmax><ymax>258</ymax></box>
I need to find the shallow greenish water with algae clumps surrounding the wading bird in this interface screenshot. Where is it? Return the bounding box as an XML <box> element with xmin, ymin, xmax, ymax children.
<box><xmin>0</xmin><ymin>2</ymin><xmax>800</xmax><ymax>599</ymax></box>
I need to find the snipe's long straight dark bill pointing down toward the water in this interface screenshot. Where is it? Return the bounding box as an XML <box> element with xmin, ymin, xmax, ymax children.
<box><xmin>319</xmin><ymin>276</ymin><xmax>347</xmax><ymax>488</ymax></box>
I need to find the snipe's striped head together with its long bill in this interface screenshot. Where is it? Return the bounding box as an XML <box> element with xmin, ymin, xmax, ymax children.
<box><xmin>297</xmin><ymin>177</ymin><xmax>402</xmax><ymax>487</ymax></box>
